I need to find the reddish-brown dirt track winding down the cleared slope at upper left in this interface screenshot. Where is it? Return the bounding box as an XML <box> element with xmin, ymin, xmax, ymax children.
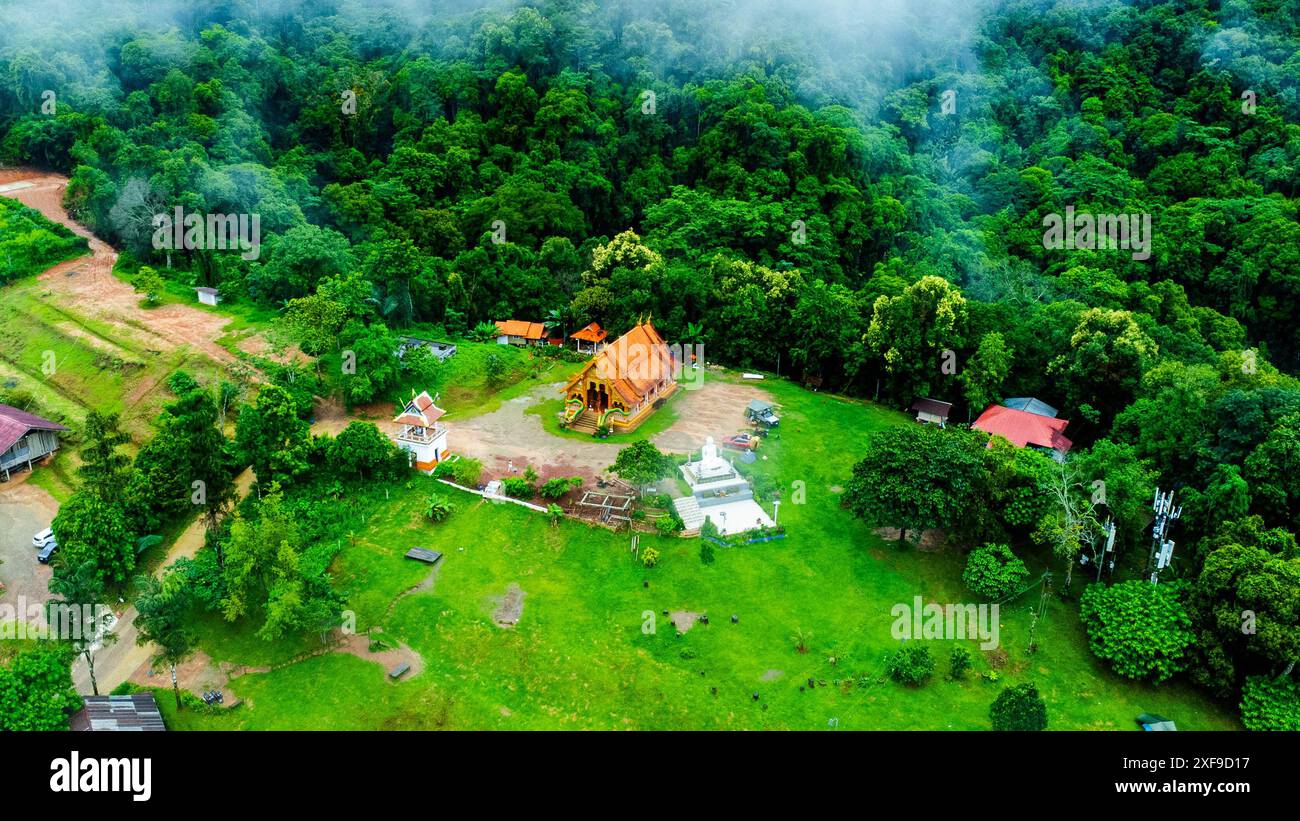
<box><xmin>0</xmin><ymin>169</ymin><xmax>238</xmax><ymax>365</ymax></box>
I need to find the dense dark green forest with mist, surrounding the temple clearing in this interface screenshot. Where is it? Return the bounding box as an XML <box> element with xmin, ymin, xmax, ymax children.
<box><xmin>0</xmin><ymin>0</ymin><xmax>1300</xmax><ymax>729</ymax></box>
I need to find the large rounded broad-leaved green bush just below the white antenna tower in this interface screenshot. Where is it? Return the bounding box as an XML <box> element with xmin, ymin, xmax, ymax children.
<box><xmin>1079</xmin><ymin>581</ymin><xmax>1193</xmax><ymax>682</ymax></box>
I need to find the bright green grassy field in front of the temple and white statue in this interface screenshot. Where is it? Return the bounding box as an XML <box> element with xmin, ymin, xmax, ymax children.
<box><xmin>160</xmin><ymin>371</ymin><xmax>1238</xmax><ymax>729</ymax></box>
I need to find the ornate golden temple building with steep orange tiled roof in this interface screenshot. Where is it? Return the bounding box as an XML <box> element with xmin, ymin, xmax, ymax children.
<box><xmin>563</xmin><ymin>320</ymin><xmax>677</xmax><ymax>433</ymax></box>
